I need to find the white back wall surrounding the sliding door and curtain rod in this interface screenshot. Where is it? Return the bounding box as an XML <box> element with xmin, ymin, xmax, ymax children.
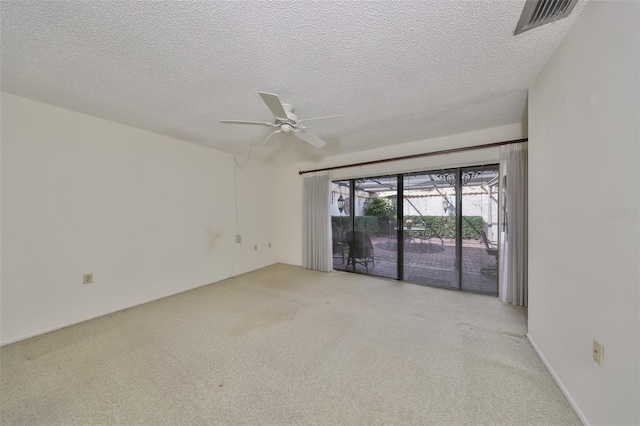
<box><xmin>278</xmin><ymin>124</ymin><xmax>527</xmax><ymax>265</ymax></box>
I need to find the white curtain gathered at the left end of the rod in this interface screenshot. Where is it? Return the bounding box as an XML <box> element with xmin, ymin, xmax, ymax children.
<box><xmin>302</xmin><ymin>173</ymin><xmax>333</xmax><ymax>272</ymax></box>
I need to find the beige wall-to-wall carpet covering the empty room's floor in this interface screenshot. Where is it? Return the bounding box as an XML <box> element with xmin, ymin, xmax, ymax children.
<box><xmin>0</xmin><ymin>265</ymin><xmax>580</xmax><ymax>425</ymax></box>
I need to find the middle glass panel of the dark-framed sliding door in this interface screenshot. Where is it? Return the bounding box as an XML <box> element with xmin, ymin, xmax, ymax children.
<box><xmin>403</xmin><ymin>170</ymin><xmax>459</xmax><ymax>288</ymax></box>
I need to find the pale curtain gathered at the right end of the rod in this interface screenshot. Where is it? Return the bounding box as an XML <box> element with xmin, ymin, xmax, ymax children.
<box><xmin>498</xmin><ymin>142</ymin><xmax>528</xmax><ymax>306</ymax></box>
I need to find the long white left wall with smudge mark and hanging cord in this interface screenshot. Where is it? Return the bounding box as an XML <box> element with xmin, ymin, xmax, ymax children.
<box><xmin>0</xmin><ymin>93</ymin><xmax>276</xmax><ymax>343</ymax></box>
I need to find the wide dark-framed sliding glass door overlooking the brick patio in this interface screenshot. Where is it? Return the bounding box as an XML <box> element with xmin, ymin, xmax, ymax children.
<box><xmin>331</xmin><ymin>165</ymin><xmax>499</xmax><ymax>295</ymax></box>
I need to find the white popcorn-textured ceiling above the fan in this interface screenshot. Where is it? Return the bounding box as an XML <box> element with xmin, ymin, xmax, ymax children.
<box><xmin>1</xmin><ymin>0</ymin><xmax>586</xmax><ymax>164</ymax></box>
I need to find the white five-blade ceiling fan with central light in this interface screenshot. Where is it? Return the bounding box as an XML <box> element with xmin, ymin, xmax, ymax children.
<box><xmin>220</xmin><ymin>92</ymin><xmax>344</xmax><ymax>148</ymax></box>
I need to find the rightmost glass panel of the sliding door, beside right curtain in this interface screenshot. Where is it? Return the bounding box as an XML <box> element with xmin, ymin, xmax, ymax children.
<box><xmin>461</xmin><ymin>166</ymin><xmax>499</xmax><ymax>295</ymax></box>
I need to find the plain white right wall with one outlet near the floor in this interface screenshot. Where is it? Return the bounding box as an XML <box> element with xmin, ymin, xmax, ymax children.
<box><xmin>529</xmin><ymin>1</ymin><xmax>640</xmax><ymax>425</ymax></box>
